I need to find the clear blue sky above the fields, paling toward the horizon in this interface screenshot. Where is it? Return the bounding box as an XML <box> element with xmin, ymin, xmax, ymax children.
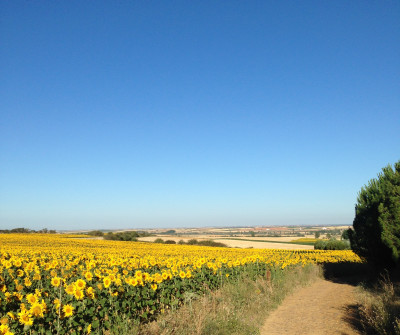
<box><xmin>0</xmin><ymin>1</ymin><xmax>400</xmax><ymax>229</ymax></box>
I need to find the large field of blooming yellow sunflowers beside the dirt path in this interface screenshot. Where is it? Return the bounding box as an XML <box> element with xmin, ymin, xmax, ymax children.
<box><xmin>0</xmin><ymin>234</ymin><xmax>361</xmax><ymax>335</ymax></box>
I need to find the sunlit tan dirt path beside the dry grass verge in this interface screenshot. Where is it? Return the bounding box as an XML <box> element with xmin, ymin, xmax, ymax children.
<box><xmin>261</xmin><ymin>279</ymin><xmax>361</xmax><ymax>335</ymax></box>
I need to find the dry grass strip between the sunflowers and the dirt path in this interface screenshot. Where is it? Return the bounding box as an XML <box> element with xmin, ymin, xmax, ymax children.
<box><xmin>119</xmin><ymin>265</ymin><xmax>321</xmax><ymax>335</ymax></box>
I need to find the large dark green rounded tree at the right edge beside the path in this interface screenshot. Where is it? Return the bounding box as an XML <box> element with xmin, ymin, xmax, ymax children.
<box><xmin>349</xmin><ymin>161</ymin><xmax>400</xmax><ymax>266</ymax></box>
